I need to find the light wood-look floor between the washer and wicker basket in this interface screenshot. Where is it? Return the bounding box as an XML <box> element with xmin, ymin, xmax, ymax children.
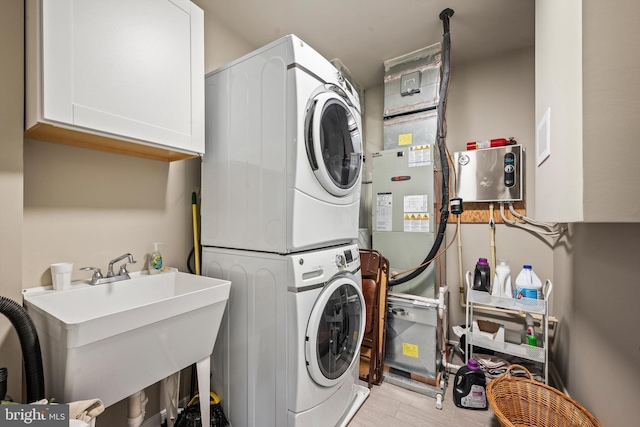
<box><xmin>349</xmin><ymin>378</ymin><xmax>500</xmax><ymax>427</ymax></box>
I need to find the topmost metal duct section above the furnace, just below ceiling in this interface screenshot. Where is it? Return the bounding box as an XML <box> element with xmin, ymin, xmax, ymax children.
<box><xmin>383</xmin><ymin>43</ymin><xmax>442</xmax><ymax>117</ymax></box>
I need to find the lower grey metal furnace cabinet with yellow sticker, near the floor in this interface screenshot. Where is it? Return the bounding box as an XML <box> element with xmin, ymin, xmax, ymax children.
<box><xmin>384</xmin><ymin>295</ymin><xmax>442</xmax><ymax>379</ymax></box>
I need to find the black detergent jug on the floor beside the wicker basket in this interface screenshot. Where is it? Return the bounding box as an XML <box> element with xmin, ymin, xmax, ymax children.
<box><xmin>453</xmin><ymin>359</ymin><xmax>487</xmax><ymax>410</ymax></box>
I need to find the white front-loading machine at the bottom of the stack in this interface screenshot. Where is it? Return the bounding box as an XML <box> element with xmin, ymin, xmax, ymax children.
<box><xmin>202</xmin><ymin>244</ymin><xmax>369</xmax><ymax>427</ymax></box>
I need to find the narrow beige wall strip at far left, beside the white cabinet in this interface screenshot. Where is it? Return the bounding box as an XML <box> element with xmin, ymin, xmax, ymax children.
<box><xmin>0</xmin><ymin>1</ymin><xmax>24</xmax><ymax>401</ymax></box>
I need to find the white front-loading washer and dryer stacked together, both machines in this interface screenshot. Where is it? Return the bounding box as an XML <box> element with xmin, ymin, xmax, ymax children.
<box><xmin>201</xmin><ymin>35</ymin><xmax>368</xmax><ymax>427</ymax></box>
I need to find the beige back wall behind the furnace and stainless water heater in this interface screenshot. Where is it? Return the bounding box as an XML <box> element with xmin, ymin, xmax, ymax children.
<box><xmin>362</xmin><ymin>44</ymin><xmax>553</xmax><ymax>339</ymax></box>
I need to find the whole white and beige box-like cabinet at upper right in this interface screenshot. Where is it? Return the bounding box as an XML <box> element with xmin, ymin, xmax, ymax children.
<box><xmin>534</xmin><ymin>0</ymin><xmax>640</xmax><ymax>223</ymax></box>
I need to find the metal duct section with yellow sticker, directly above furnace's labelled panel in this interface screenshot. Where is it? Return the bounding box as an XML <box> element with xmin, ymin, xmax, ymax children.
<box><xmin>383</xmin><ymin>110</ymin><xmax>438</xmax><ymax>150</ymax></box>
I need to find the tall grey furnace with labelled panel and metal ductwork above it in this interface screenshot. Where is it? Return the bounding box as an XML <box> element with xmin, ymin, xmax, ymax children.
<box><xmin>372</xmin><ymin>43</ymin><xmax>444</xmax><ymax>298</ymax></box>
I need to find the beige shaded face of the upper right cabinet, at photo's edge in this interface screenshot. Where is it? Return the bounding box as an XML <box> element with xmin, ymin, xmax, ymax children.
<box><xmin>584</xmin><ymin>0</ymin><xmax>640</xmax><ymax>222</ymax></box>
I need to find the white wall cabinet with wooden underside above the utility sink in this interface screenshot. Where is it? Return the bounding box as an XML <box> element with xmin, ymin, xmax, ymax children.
<box><xmin>25</xmin><ymin>0</ymin><xmax>204</xmax><ymax>161</ymax></box>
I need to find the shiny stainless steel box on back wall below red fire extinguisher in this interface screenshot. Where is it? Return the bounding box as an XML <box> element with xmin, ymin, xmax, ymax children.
<box><xmin>453</xmin><ymin>145</ymin><xmax>525</xmax><ymax>202</ymax></box>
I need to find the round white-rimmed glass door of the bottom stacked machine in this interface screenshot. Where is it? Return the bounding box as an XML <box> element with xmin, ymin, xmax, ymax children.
<box><xmin>305</xmin><ymin>276</ymin><xmax>366</xmax><ymax>387</ymax></box>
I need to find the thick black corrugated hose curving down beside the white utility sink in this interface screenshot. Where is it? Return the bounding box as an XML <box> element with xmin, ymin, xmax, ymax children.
<box><xmin>0</xmin><ymin>297</ymin><xmax>45</xmax><ymax>403</ymax></box>
